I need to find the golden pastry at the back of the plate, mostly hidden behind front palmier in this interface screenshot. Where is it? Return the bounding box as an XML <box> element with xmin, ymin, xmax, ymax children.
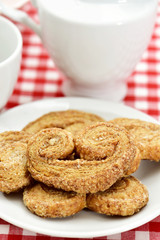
<box><xmin>23</xmin><ymin>110</ymin><xmax>105</xmax><ymax>133</ymax></box>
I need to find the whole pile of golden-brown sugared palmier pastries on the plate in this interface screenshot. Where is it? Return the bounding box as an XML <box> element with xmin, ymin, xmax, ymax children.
<box><xmin>0</xmin><ymin>110</ymin><xmax>160</xmax><ymax>218</ymax></box>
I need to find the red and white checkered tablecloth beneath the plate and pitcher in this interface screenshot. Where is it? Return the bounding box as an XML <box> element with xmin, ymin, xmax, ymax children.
<box><xmin>0</xmin><ymin>0</ymin><xmax>160</xmax><ymax>240</ymax></box>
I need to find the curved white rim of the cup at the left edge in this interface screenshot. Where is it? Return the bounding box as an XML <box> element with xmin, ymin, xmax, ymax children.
<box><xmin>0</xmin><ymin>16</ymin><xmax>23</xmax><ymax>67</ymax></box>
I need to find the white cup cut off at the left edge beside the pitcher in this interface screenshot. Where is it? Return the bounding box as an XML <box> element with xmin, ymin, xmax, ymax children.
<box><xmin>0</xmin><ymin>16</ymin><xmax>22</xmax><ymax>109</ymax></box>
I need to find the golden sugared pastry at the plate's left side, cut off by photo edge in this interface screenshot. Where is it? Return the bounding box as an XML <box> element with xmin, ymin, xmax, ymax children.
<box><xmin>0</xmin><ymin>131</ymin><xmax>31</xmax><ymax>193</ymax></box>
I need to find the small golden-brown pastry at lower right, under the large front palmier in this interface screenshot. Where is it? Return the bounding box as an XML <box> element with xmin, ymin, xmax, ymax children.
<box><xmin>87</xmin><ymin>176</ymin><xmax>149</xmax><ymax>216</ymax></box>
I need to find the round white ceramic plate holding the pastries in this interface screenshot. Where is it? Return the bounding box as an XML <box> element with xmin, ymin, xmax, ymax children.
<box><xmin>0</xmin><ymin>98</ymin><xmax>160</xmax><ymax>238</ymax></box>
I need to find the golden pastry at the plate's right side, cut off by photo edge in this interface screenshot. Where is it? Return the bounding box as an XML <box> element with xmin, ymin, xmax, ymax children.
<box><xmin>110</xmin><ymin>118</ymin><xmax>160</xmax><ymax>162</ymax></box>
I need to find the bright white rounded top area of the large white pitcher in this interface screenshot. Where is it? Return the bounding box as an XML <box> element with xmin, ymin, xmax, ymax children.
<box><xmin>39</xmin><ymin>0</ymin><xmax>157</xmax><ymax>24</ymax></box>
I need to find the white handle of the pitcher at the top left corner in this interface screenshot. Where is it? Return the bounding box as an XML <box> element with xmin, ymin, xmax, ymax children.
<box><xmin>0</xmin><ymin>2</ymin><xmax>41</xmax><ymax>38</ymax></box>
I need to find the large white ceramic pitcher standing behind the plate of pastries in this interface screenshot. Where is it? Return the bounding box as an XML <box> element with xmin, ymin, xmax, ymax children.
<box><xmin>1</xmin><ymin>0</ymin><xmax>158</xmax><ymax>101</ymax></box>
